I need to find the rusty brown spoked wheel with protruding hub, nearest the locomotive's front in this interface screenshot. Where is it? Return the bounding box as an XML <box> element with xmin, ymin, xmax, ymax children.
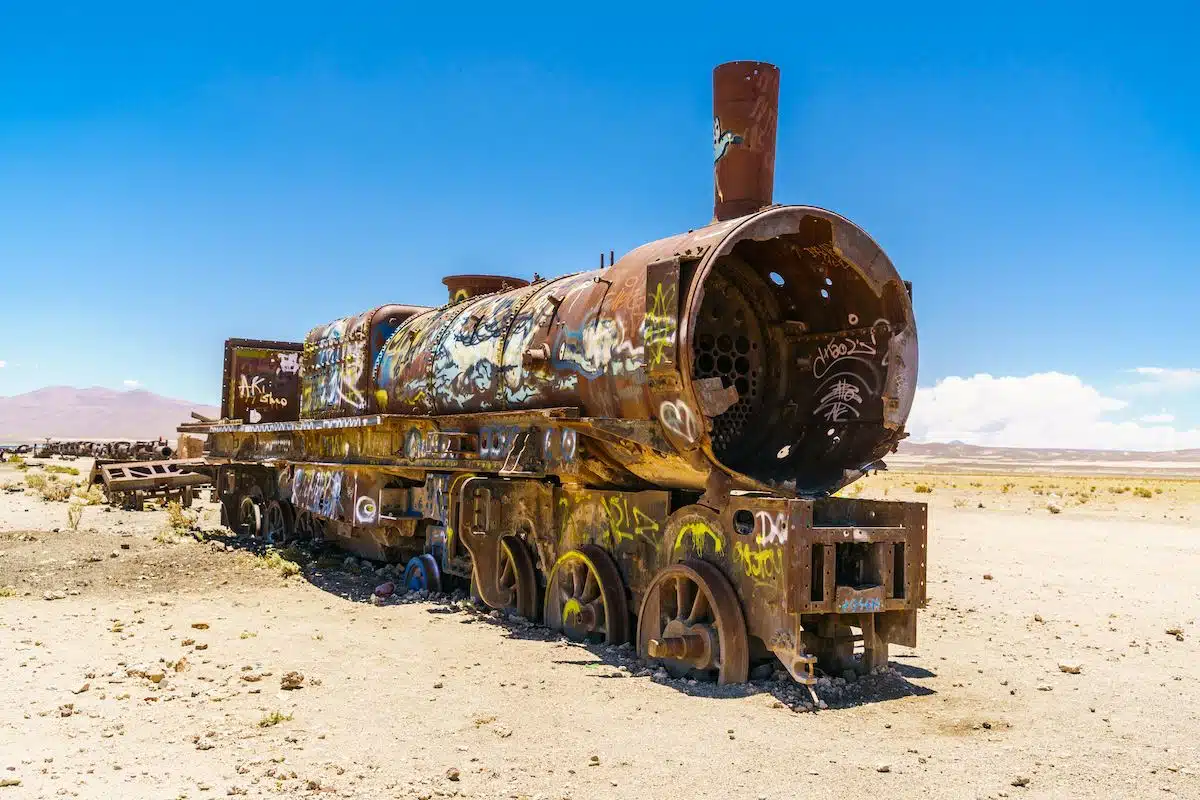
<box><xmin>637</xmin><ymin>560</ymin><xmax>750</xmax><ymax>684</ymax></box>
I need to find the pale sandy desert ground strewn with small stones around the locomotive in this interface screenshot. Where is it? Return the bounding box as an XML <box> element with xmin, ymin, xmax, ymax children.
<box><xmin>0</xmin><ymin>459</ymin><xmax>1200</xmax><ymax>800</ymax></box>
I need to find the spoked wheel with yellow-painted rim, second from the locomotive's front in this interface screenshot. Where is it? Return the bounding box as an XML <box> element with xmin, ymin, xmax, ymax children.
<box><xmin>544</xmin><ymin>545</ymin><xmax>629</xmax><ymax>644</ymax></box>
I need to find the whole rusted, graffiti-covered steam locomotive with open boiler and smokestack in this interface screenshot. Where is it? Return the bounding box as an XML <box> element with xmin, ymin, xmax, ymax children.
<box><xmin>180</xmin><ymin>62</ymin><xmax>926</xmax><ymax>682</ymax></box>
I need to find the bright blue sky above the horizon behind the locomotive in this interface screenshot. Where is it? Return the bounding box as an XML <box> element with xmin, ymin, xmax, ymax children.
<box><xmin>0</xmin><ymin>0</ymin><xmax>1200</xmax><ymax>447</ymax></box>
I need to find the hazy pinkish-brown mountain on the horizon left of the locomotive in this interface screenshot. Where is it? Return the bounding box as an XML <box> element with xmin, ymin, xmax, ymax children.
<box><xmin>0</xmin><ymin>386</ymin><xmax>220</xmax><ymax>443</ymax></box>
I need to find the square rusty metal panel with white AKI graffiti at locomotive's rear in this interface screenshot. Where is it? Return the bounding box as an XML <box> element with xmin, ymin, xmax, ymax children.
<box><xmin>221</xmin><ymin>338</ymin><xmax>304</xmax><ymax>422</ymax></box>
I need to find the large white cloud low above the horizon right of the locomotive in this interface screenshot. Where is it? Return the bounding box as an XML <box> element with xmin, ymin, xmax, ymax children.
<box><xmin>907</xmin><ymin>372</ymin><xmax>1200</xmax><ymax>450</ymax></box>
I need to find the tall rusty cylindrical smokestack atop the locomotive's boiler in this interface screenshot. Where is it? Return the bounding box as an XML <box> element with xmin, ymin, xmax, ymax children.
<box><xmin>713</xmin><ymin>61</ymin><xmax>779</xmax><ymax>221</ymax></box>
